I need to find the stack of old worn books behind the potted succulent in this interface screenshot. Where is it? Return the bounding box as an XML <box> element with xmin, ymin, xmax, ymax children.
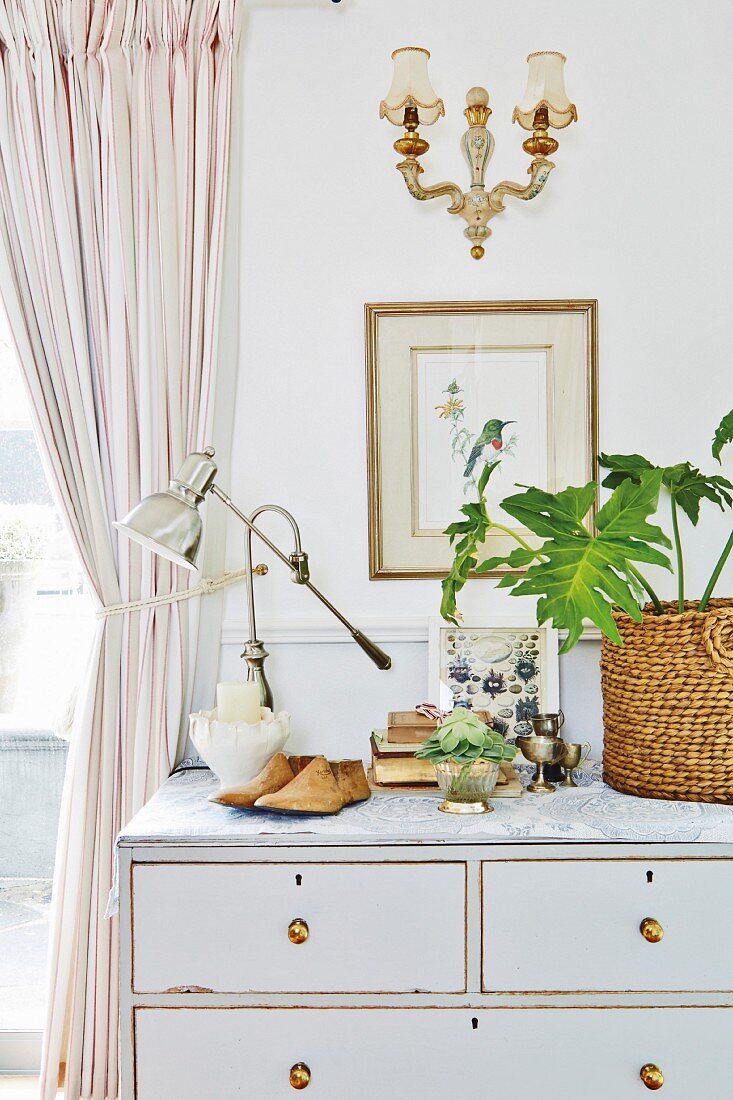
<box><xmin>369</xmin><ymin>711</ymin><xmax>522</xmax><ymax>796</ymax></box>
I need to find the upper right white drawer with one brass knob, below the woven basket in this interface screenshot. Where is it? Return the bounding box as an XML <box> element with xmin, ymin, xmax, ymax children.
<box><xmin>482</xmin><ymin>859</ymin><xmax>733</xmax><ymax>998</ymax></box>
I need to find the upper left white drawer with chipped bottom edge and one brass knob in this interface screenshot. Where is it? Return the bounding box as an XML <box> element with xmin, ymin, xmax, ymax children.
<box><xmin>132</xmin><ymin>862</ymin><xmax>466</xmax><ymax>993</ymax></box>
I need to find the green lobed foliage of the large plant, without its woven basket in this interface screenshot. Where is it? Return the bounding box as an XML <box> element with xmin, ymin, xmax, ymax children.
<box><xmin>441</xmin><ymin>410</ymin><xmax>733</xmax><ymax>652</ymax></box>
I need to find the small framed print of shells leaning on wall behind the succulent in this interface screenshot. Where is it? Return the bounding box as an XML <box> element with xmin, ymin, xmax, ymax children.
<box><xmin>428</xmin><ymin>615</ymin><xmax>560</xmax><ymax>741</ymax></box>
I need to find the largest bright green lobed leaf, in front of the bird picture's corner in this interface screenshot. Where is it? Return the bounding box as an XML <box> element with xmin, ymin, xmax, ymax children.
<box><xmin>477</xmin><ymin>470</ymin><xmax>670</xmax><ymax>652</ymax></box>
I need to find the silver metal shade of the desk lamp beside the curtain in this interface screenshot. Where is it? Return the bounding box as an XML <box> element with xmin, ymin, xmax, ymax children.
<box><xmin>114</xmin><ymin>448</ymin><xmax>217</xmax><ymax>569</ymax></box>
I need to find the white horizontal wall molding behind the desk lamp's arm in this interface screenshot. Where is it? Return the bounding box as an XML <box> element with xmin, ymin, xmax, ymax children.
<box><xmin>221</xmin><ymin>616</ymin><xmax>601</xmax><ymax>646</ymax></box>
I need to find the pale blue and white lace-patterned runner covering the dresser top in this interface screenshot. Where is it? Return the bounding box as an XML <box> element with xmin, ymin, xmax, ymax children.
<box><xmin>120</xmin><ymin>763</ymin><xmax>733</xmax><ymax>844</ymax></box>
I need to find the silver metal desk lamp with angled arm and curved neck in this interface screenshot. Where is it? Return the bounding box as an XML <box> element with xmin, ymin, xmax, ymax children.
<box><xmin>114</xmin><ymin>447</ymin><xmax>392</xmax><ymax>710</ymax></box>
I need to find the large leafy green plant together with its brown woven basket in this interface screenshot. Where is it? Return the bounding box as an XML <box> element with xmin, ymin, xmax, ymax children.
<box><xmin>441</xmin><ymin>411</ymin><xmax>733</xmax><ymax>803</ymax></box>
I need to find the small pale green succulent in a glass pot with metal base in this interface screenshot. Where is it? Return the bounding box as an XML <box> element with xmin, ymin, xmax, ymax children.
<box><xmin>415</xmin><ymin>706</ymin><xmax>516</xmax><ymax>814</ymax></box>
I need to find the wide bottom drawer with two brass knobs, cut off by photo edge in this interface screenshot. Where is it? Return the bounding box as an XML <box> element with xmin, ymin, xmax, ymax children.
<box><xmin>134</xmin><ymin>1008</ymin><xmax>733</xmax><ymax>1100</ymax></box>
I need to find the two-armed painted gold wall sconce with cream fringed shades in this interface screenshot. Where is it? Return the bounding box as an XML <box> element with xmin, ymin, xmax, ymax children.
<box><xmin>380</xmin><ymin>46</ymin><xmax>578</xmax><ymax>260</ymax></box>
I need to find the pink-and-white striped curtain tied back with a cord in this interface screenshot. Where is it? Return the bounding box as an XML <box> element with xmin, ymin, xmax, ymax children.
<box><xmin>0</xmin><ymin>0</ymin><xmax>242</xmax><ymax>1100</ymax></box>
